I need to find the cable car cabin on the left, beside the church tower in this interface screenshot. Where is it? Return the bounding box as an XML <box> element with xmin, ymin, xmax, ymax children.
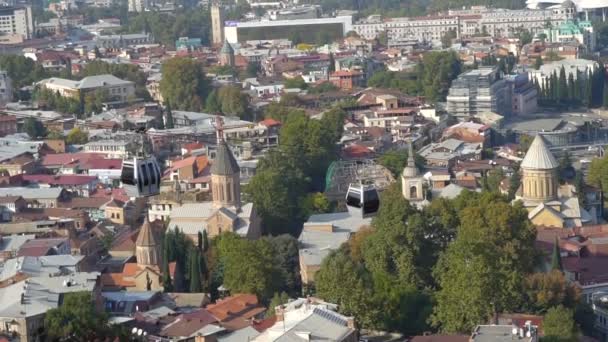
<box><xmin>120</xmin><ymin>157</ymin><xmax>161</xmax><ymax>197</ymax></box>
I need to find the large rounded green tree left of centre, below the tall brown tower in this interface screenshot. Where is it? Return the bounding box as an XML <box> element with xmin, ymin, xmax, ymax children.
<box><xmin>160</xmin><ymin>57</ymin><xmax>210</xmax><ymax>111</ymax></box>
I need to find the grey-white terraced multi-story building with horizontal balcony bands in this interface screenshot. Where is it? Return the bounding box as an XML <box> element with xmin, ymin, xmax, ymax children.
<box><xmin>447</xmin><ymin>67</ymin><xmax>512</xmax><ymax>118</ymax></box>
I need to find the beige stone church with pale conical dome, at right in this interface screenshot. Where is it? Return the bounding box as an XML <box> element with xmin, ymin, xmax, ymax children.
<box><xmin>516</xmin><ymin>134</ymin><xmax>597</xmax><ymax>228</ymax></box>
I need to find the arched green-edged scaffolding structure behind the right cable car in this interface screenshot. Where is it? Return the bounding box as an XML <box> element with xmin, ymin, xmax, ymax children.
<box><xmin>325</xmin><ymin>159</ymin><xmax>395</xmax><ymax>200</ymax></box>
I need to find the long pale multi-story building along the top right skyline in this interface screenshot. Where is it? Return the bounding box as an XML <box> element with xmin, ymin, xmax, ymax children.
<box><xmin>353</xmin><ymin>6</ymin><xmax>572</xmax><ymax>41</ymax></box>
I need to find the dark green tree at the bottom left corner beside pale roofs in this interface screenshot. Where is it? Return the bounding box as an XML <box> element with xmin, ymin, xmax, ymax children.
<box><xmin>44</xmin><ymin>292</ymin><xmax>114</xmax><ymax>341</ymax></box>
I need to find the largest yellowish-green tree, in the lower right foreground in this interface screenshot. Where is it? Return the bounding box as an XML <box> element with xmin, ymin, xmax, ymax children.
<box><xmin>432</xmin><ymin>193</ymin><xmax>536</xmax><ymax>332</ymax></box>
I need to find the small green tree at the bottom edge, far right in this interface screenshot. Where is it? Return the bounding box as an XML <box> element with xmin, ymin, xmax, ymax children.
<box><xmin>543</xmin><ymin>305</ymin><xmax>578</xmax><ymax>342</ymax></box>
